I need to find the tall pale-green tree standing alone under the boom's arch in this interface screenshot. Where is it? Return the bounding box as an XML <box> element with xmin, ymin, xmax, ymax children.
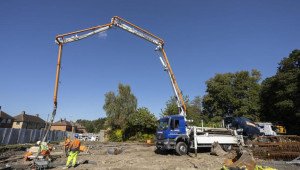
<box><xmin>103</xmin><ymin>83</ymin><xmax>137</xmax><ymax>131</ymax></box>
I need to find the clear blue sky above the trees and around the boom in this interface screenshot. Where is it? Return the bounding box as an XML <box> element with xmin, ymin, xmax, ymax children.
<box><xmin>0</xmin><ymin>0</ymin><xmax>300</xmax><ymax>121</ymax></box>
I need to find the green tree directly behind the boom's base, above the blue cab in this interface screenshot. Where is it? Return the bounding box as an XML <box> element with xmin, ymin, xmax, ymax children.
<box><xmin>161</xmin><ymin>96</ymin><xmax>207</xmax><ymax>125</ymax></box>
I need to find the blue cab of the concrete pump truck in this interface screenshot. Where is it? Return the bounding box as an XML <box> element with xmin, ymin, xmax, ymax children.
<box><xmin>155</xmin><ymin>115</ymin><xmax>188</xmax><ymax>150</ymax></box>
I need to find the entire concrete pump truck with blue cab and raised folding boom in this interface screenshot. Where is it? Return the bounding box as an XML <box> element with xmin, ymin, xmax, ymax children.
<box><xmin>43</xmin><ymin>16</ymin><xmax>240</xmax><ymax>155</ymax></box>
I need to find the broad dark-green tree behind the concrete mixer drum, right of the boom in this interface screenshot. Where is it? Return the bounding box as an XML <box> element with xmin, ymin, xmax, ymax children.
<box><xmin>203</xmin><ymin>70</ymin><xmax>261</xmax><ymax>121</ymax></box>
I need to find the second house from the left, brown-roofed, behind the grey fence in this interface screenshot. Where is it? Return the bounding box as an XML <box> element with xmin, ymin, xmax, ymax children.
<box><xmin>12</xmin><ymin>111</ymin><xmax>46</xmax><ymax>129</ymax></box>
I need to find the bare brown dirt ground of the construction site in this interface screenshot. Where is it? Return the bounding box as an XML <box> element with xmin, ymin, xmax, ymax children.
<box><xmin>0</xmin><ymin>142</ymin><xmax>300</xmax><ymax>170</ymax></box>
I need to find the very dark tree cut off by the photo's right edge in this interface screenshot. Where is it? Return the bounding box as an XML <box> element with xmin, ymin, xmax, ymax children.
<box><xmin>260</xmin><ymin>50</ymin><xmax>300</xmax><ymax>135</ymax></box>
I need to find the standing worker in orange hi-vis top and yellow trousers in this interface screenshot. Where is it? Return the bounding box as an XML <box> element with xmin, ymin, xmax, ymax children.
<box><xmin>63</xmin><ymin>134</ymin><xmax>80</xmax><ymax>169</ymax></box>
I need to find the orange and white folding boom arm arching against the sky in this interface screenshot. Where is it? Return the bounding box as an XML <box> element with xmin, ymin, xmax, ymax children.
<box><xmin>54</xmin><ymin>16</ymin><xmax>186</xmax><ymax>117</ymax></box>
